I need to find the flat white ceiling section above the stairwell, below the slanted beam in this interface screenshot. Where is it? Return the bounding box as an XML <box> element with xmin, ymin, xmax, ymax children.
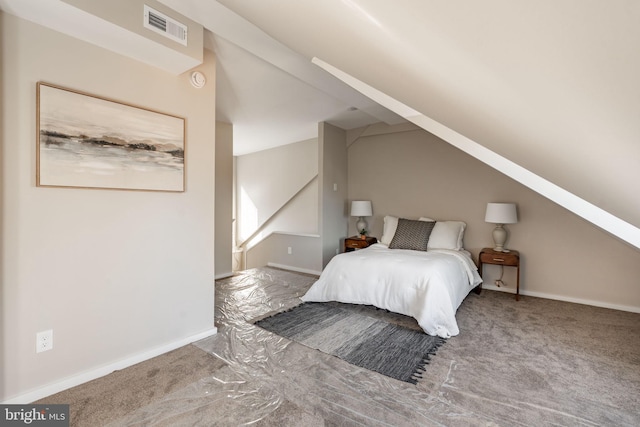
<box><xmin>212</xmin><ymin>33</ymin><xmax>401</xmax><ymax>156</ymax></box>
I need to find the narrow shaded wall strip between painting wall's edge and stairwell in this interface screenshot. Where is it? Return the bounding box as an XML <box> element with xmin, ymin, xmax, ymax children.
<box><xmin>215</xmin><ymin>122</ymin><xmax>233</xmax><ymax>278</ymax></box>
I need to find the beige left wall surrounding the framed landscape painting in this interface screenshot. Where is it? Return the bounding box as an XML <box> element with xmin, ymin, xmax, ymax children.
<box><xmin>0</xmin><ymin>14</ymin><xmax>215</xmax><ymax>400</ymax></box>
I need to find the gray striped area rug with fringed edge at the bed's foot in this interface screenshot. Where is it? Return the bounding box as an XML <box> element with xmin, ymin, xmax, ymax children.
<box><xmin>255</xmin><ymin>303</ymin><xmax>446</xmax><ymax>384</ymax></box>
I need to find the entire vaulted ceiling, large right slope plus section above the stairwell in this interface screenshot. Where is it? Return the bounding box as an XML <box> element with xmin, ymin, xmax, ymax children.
<box><xmin>5</xmin><ymin>0</ymin><xmax>640</xmax><ymax>248</ymax></box>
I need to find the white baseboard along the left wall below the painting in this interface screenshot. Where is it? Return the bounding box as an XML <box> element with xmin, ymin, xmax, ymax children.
<box><xmin>2</xmin><ymin>327</ymin><xmax>218</xmax><ymax>405</ymax></box>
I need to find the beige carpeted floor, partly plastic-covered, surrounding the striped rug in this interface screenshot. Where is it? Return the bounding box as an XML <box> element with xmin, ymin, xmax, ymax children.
<box><xmin>35</xmin><ymin>268</ymin><xmax>640</xmax><ymax>427</ymax></box>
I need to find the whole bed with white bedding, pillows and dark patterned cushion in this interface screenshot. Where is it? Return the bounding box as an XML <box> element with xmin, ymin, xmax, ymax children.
<box><xmin>302</xmin><ymin>216</ymin><xmax>482</xmax><ymax>338</ymax></box>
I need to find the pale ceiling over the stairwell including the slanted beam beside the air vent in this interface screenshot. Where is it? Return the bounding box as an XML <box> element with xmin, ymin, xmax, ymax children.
<box><xmin>160</xmin><ymin>0</ymin><xmax>404</xmax><ymax>155</ymax></box>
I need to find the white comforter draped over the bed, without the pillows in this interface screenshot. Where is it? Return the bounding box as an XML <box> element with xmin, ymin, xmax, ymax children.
<box><xmin>302</xmin><ymin>243</ymin><xmax>482</xmax><ymax>338</ymax></box>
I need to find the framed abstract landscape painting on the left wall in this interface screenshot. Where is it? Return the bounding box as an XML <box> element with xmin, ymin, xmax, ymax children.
<box><xmin>36</xmin><ymin>82</ymin><xmax>185</xmax><ymax>192</ymax></box>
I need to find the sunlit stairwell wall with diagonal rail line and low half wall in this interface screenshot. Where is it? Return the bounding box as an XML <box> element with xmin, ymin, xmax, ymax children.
<box><xmin>235</xmin><ymin>139</ymin><xmax>321</xmax><ymax>272</ymax></box>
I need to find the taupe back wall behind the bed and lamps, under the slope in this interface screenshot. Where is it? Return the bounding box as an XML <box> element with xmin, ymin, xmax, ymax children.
<box><xmin>348</xmin><ymin>123</ymin><xmax>640</xmax><ymax>311</ymax></box>
